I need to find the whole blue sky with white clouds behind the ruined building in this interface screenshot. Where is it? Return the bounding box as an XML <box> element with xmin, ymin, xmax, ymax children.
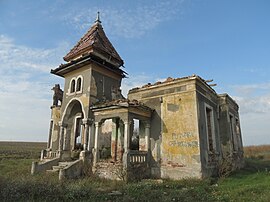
<box><xmin>0</xmin><ymin>0</ymin><xmax>270</xmax><ymax>145</ymax></box>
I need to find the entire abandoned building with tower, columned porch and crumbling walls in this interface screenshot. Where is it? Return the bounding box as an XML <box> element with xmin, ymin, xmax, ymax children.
<box><xmin>31</xmin><ymin>12</ymin><xmax>243</xmax><ymax>179</ymax></box>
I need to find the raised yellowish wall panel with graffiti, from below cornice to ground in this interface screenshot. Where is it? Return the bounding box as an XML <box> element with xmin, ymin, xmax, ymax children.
<box><xmin>161</xmin><ymin>89</ymin><xmax>201</xmax><ymax>179</ymax></box>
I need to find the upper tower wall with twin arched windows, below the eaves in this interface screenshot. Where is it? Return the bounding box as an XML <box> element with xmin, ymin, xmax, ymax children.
<box><xmin>61</xmin><ymin>63</ymin><xmax>122</xmax><ymax>118</ymax></box>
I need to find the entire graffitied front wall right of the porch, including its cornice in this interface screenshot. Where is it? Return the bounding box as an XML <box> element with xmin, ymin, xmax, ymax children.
<box><xmin>128</xmin><ymin>80</ymin><xmax>201</xmax><ymax>179</ymax></box>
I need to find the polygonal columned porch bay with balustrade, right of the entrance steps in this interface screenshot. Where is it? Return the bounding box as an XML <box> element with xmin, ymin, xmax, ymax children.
<box><xmin>90</xmin><ymin>100</ymin><xmax>152</xmax><ymax>179</ymax></box>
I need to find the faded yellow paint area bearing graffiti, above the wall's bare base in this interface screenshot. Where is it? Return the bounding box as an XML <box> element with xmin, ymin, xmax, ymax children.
<box><xmin>162</xmin><ymin>93</ymin><xmax>199</xmax><ymax>164</ymax></box>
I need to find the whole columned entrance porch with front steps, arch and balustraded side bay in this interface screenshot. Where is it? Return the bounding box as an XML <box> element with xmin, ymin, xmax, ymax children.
<box><xmin>32</xmin><ymin>100</ymin><xmax>152</xmax><ymax>180</ymax></box>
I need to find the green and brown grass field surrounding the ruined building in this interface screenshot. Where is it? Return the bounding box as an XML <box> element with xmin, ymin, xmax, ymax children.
<box><xmin>0</xmin><ymin>142</ymin><xmax>270</xmax><ymax>201</ymax></box>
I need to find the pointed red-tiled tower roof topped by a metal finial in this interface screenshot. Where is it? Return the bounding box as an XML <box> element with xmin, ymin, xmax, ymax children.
<box><xmin>63</xmin><ymin>12</ymin><xmax>124</xmax><ymax>67</ymax></box>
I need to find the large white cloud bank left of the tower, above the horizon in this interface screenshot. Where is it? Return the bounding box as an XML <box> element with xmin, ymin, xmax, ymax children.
<box><xmin>0</xmin><ymin>35</ymin><xmax>66</xmax><ymax>141</ymax></box>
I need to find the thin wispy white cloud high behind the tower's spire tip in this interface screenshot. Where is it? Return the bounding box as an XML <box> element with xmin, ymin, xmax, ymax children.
<box><xmin>65</xmin><ymin>0</ymin><xmax>184</xmax><ymax>38</ymax></box>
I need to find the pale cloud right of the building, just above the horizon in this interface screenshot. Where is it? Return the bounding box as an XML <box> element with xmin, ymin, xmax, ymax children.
<box><xmin>229</xmin><ymin>83</ymin><xmax>270</xmax><ymax>145</ymax></box>
